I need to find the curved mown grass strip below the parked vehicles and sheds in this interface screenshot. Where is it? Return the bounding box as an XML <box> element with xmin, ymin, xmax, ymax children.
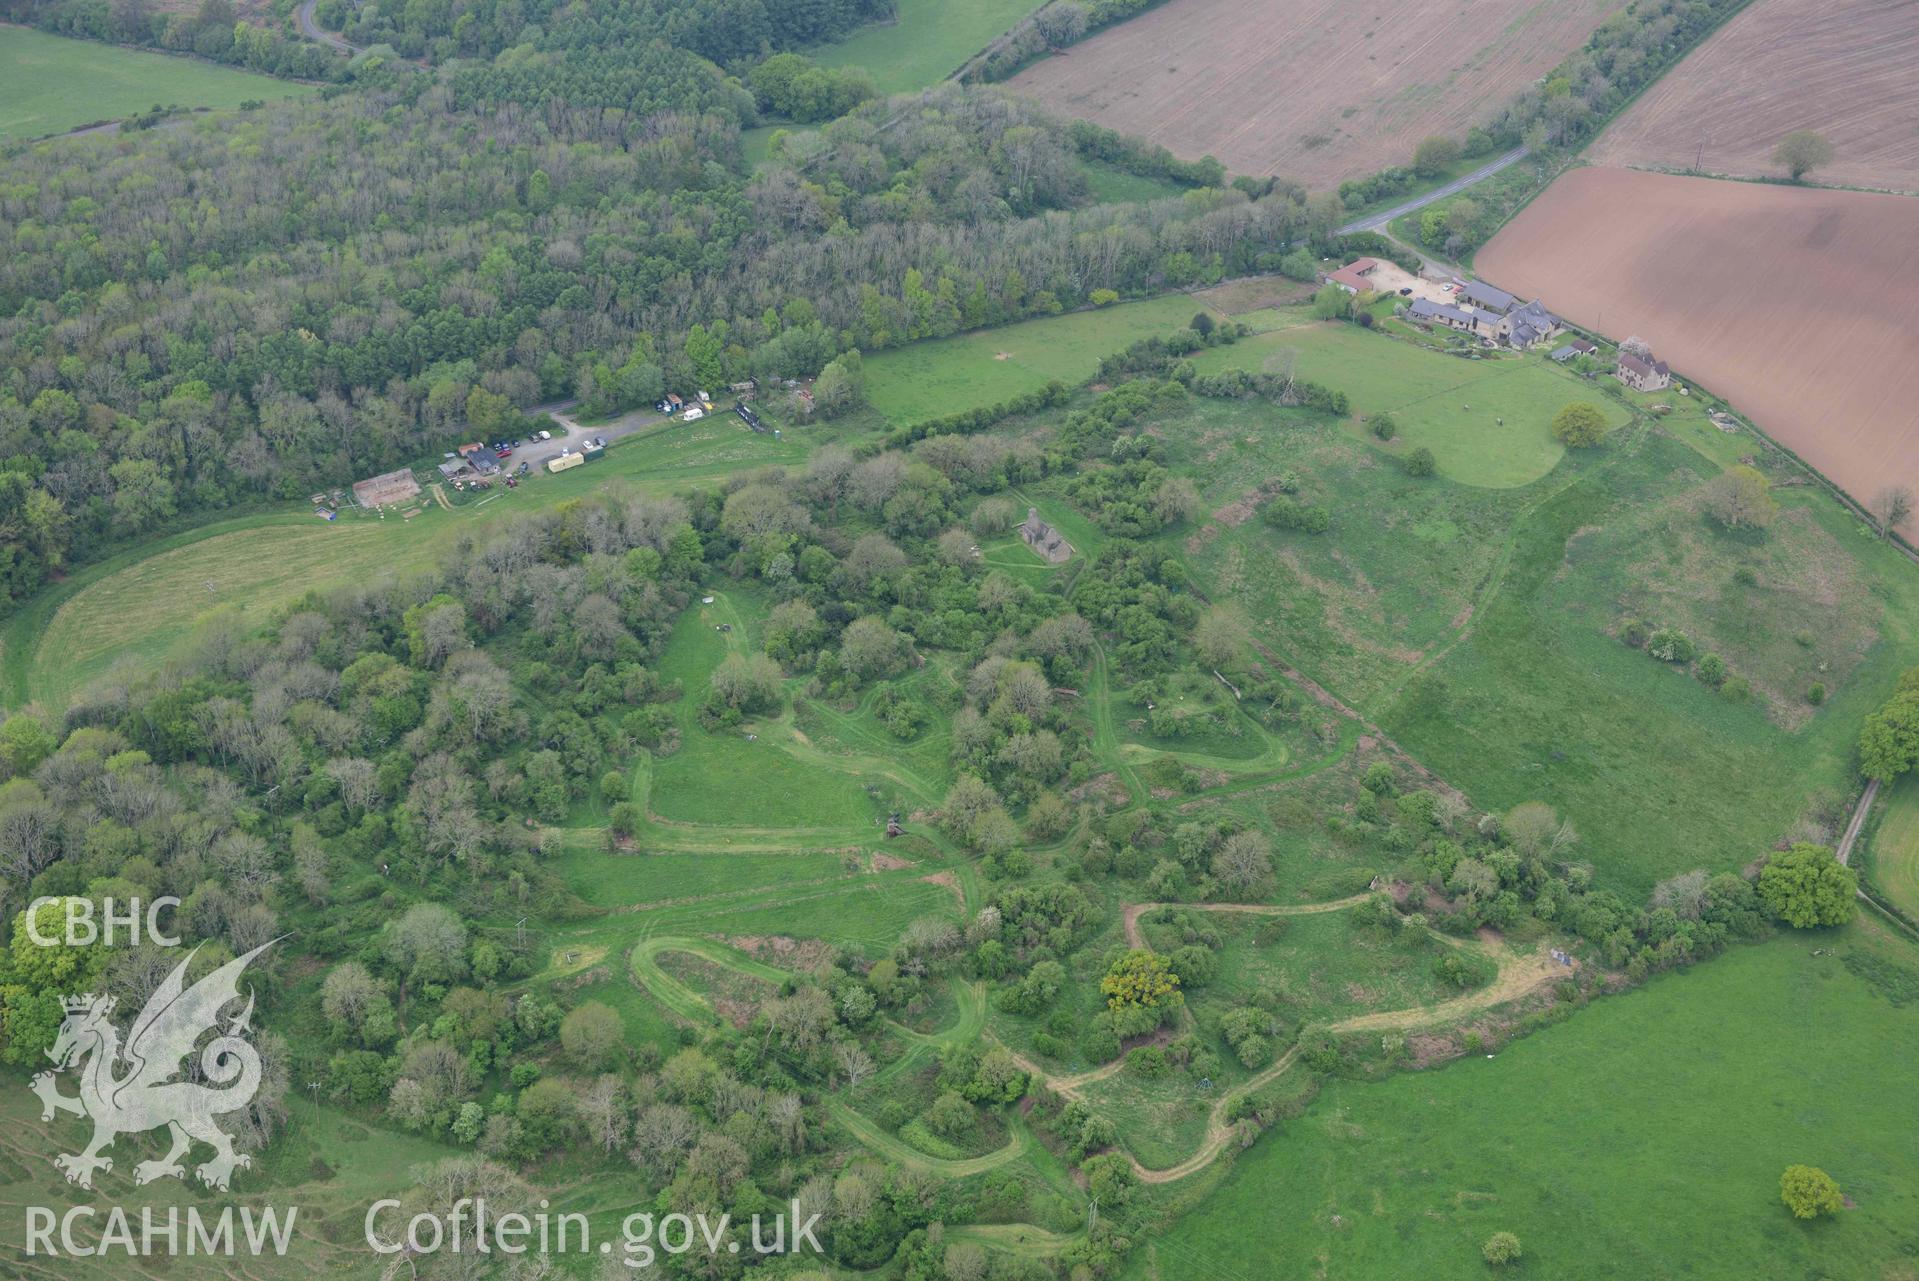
<box><xmin>0</xmin><ymin>416</ymin><xmax>812</xmax><ymax>708</ymax></box>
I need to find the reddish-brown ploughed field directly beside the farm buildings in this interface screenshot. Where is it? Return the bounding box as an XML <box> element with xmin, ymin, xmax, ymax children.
<box><xmin>1476</xmin><ymin>169</ymin><xmax>1919</xmax><ymax>501</ymax></box>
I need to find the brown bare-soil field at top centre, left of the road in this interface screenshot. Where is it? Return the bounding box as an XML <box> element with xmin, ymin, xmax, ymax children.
<box><xmin>1011</xmin><ymin>0</ymin><xmax>1620</xmax><ymax>190</ymax></box>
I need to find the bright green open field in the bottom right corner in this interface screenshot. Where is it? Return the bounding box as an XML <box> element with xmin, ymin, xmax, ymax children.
<box><xmin>1126</xmin><ymin>926</ymin><xmax>1919</xmax><ymax>1281</ymax></box>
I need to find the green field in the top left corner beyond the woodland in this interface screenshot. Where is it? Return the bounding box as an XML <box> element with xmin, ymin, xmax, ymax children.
<box><xmin>0</xmin><ymin>25</ymin><xmax>313</xmax><ymax>142</ymax></box>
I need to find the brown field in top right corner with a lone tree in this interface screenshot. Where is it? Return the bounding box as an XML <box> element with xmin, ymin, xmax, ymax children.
<box><xmin>1589</xmin><ymin>0</ymin><xmax>1919</xmax><ymax>192</ymax></box>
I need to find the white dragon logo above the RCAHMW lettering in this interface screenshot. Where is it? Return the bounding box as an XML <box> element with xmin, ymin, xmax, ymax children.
<box><xmin>33</xmin><ymin>940</ymin><xmax>278</xmax><ymax>1191</ymax></box>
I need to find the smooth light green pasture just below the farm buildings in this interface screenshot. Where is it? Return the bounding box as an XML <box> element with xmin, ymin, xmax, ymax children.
<box><xmin>1194</xmin><ymin>313</ymin><xmax>1627</xmax><ymax>489</ymax></box>
